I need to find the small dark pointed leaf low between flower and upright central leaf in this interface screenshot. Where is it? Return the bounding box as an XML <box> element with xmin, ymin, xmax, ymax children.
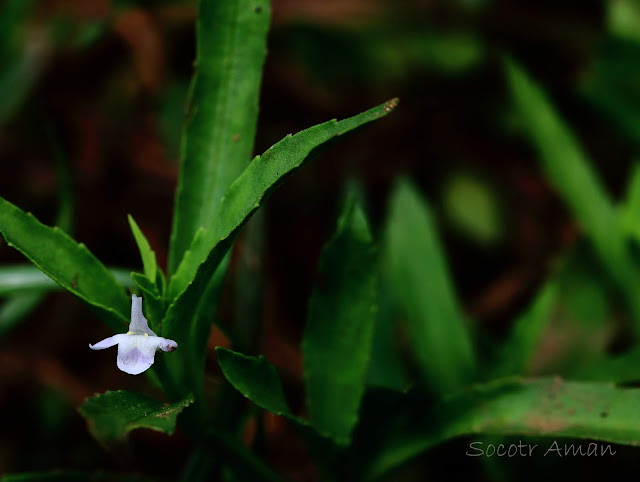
<box><xmin>216</xmin><ymin>347</ymin><xmax>296</xmax><ymax>419</ymax></box>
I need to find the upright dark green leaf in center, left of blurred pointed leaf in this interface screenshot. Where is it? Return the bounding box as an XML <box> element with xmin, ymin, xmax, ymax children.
<box><xmin>302</xmin><ymin>197</ymin><xmax>378</xmax><ymax>444</ymax></box>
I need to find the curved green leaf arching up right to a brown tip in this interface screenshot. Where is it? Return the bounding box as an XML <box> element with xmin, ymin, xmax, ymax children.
<box><xmin>168</xmin><ymin>99</ymin><xmax>398</xmax><ymax>299</ymax></box>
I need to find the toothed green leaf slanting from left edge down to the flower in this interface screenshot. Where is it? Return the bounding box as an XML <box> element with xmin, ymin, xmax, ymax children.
<box><xmin>0</xmin><ymin>198</ymin><xmax>130</xmax><ymax>332</ymax></box>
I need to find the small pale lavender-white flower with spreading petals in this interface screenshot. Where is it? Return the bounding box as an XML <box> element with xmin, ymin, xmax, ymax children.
<box><xmin>89</xmin><ymin>295</ymin><xmax>178</xmax><ymax>375</ymax></box>
